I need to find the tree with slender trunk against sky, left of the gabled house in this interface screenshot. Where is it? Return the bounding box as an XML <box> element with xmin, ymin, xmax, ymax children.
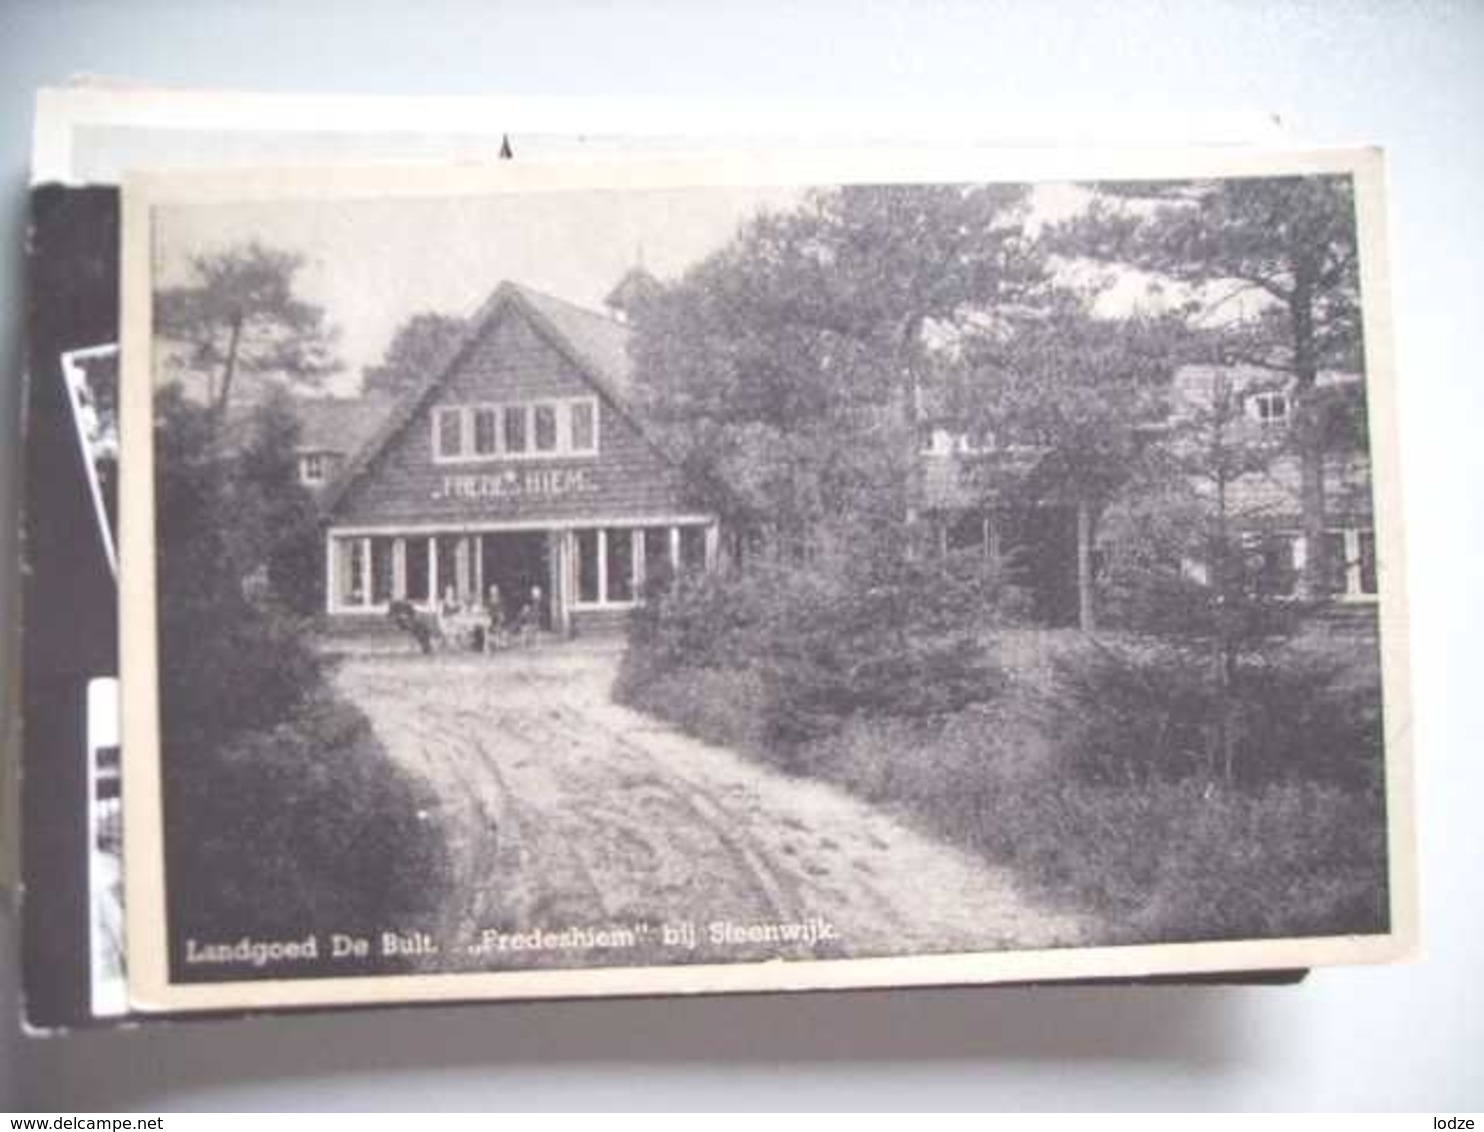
<box><xmin>154</xmin><ymin>240</ymin><xmax>338</xmax><ymax>421</ymax></box>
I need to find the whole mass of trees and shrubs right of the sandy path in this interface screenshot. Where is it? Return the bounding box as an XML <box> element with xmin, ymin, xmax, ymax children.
<box><xmin>619</xmin><ymin>177</ymin><xmax>1386</xmax><ymax>941</ymax></box>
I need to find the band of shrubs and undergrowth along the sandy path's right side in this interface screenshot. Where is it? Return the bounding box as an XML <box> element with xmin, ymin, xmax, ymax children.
<box><xmin>619</xmin><ymin>570</ymin><xmax>1388</xmax><ymax>944</ymax></box>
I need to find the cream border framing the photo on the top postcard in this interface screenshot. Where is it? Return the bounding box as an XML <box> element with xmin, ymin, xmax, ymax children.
<box><xmin>120</xmin><ymin>148</ymin><xmax>1417</xmax><ymax>1012</ymax></box>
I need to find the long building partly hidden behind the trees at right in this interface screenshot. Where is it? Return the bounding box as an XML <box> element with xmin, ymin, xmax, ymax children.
<box><xmin>917</xmin><ymin>365</ymin><xmax>1377</xmax><ymax>625</ymax></box>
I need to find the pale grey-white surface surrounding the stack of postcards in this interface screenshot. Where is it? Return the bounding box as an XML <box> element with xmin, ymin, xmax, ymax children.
<box><xmin>0</xmin><ymin>0</ymin><xmax>1484</xmax><ymax>1111</ymax></box>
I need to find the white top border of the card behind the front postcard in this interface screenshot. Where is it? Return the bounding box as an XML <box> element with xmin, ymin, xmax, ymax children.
<box><xmin>31</xmin><ymin>80</ymin><xmax>1284</xmax><ymax>184</ymax></box>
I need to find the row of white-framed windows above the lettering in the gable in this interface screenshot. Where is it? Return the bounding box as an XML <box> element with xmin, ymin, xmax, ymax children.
<box><xmin>433</xmin><ymin>398</ymin><xmax>598</xmax><ymax>463</ymax></box>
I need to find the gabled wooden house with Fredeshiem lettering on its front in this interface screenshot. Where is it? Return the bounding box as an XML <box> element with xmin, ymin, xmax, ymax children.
<box><xmin>322</xmin><ymin>282</ymin><xmax>717</xmax><ymax>632</ymax></box>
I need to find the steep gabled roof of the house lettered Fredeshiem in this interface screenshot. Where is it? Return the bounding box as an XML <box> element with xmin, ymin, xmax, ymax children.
<box><xmin>324</xmin><ymin>280</ymin><xmax>669</xmax><ymax>515</ymax></box>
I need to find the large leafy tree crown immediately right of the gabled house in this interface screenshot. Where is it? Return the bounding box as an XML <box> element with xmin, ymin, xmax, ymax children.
<box><xmin>631</xmin><ymin>185</ymin><xmax>1043</xmax><ymax>555</ymax></box>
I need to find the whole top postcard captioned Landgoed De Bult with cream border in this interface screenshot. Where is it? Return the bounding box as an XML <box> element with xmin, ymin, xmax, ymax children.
<box><xmin>120</xmin><ymin>150</ymin><xmax>1416</xmax><ymax>1010</ymax></box>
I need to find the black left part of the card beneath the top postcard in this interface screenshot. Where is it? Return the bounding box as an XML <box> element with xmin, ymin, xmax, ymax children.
<box><xmin>21</xmin><ymin>185</ymin><xmax>119</xmax><ymax>1025</ymax></box>
